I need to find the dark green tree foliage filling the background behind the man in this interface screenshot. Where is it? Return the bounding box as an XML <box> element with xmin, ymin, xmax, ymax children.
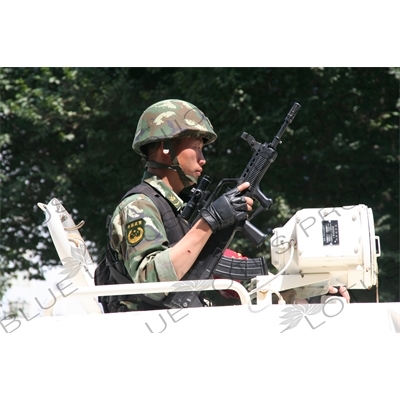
<box><xmin>0</xmin><ymin>68</ymin><xmax>400</xmax><ymax>301</ymax></box>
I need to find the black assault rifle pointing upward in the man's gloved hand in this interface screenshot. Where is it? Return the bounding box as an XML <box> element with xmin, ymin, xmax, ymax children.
<box><xmin>164</xmin><ymin>103</ymin><xmax>301</xmax><ymax>308</ymax></box>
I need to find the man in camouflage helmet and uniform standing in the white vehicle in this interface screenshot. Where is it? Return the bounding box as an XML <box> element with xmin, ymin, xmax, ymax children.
<box><xmin>104</xmin><ymin>99</ymin><xmax>253</xmax><ymax>311</ymax></box>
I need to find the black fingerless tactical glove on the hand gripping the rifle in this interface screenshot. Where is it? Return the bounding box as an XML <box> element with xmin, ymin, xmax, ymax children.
<box><xmin>200</xmin><ymin>188</ymin><xmax>247</xmax><ymax>233</ymax></box>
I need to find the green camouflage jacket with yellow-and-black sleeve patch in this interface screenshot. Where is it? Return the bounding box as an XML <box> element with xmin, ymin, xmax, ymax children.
<box><xmin>109</xmin><ymin>171</ymin><xmax>184</xmax><ymax>310</ymax></box>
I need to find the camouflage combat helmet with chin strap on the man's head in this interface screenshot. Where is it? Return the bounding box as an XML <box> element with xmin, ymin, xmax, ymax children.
<box><xmin>132</xmin><ymin>99</ymin><xmax>217</xmax><ymax>186</ymax></box>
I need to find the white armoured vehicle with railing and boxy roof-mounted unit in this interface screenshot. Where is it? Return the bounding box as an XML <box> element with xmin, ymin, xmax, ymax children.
<box><xmin>0</xmin><ymin>199</ymin><xmax>400</xmax><ymax>335</ymax></box>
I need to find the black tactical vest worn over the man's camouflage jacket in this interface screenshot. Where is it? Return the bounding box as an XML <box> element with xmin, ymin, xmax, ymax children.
<box><xmin>94</xmin><ymin>182</ymin><xmax>190</xmax><ymax>313</ymax></box>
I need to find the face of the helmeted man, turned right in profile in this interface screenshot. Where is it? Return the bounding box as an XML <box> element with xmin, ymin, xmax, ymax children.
<box><xmin>175</xmin><ymin>138</ymin><xmax>206</xmax><ymax>178</ymax></box>
